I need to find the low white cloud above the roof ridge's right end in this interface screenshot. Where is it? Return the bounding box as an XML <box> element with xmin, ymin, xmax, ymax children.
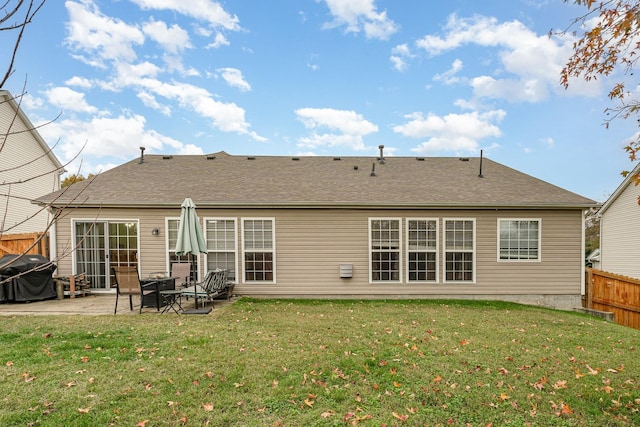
<box><xmin>393</xmin><ymin>110</ymin><xmax>506</xmax><ymax>154</ymax></box>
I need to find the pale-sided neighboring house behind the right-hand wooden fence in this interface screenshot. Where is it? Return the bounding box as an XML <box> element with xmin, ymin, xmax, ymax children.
<box><xmin>598</xmin><ymin>165</ymin><xmax>640</xmax><ymax>279</ymax></box>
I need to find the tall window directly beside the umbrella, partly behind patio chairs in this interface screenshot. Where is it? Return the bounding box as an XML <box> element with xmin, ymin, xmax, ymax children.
<box><xmin>205</xmin><ymin>218</ymin><xmax>236</xmax><ymax>281</ymax></box>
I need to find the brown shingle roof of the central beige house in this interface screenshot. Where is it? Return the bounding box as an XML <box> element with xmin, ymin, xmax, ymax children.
<box><xmin>38</xmin><ymin>152</ymin><xmax>596</xmax><ymax>208</ymax></box>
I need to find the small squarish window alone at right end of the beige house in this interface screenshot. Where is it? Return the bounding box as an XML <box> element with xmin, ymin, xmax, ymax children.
<box><xmin>498</xmin><ymin>219</ymin><xmax>540</xmax><ymax>261</ymax></box>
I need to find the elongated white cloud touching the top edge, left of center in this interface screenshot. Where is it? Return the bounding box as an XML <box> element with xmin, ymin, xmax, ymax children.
<box><xmin>130</xmin><ymin>0</ymin><xmax>241</xmax><ymax>31</ymax></box>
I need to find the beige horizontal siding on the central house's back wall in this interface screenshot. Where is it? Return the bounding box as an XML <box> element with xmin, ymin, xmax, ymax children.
<box><xmin>58</xmin><ymin>208</ymin><xmax>584</xmax><ymax>298</ymax></box>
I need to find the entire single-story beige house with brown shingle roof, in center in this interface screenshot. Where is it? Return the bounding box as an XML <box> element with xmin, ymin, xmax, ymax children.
<box><xmin>39</xmin><ymin>152</ymin><xmax>595</xmax><ymax>307</ymax></box>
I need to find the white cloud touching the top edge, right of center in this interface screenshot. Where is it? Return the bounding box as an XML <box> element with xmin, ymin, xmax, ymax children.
<box><xmin>316</xmin><ymin>0</ymin><xmax>398</xmax><ymax>40</ymax></box>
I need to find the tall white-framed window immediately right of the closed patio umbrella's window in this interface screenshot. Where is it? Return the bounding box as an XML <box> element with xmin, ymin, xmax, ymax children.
<box><xmin>242</xmin><ymin>218</ymin><xmax>275</xmax><ymax>283</ymax></box>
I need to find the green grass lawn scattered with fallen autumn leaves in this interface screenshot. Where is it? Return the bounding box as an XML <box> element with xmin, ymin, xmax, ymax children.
<box><xmin>0</xmin><ymin>299</ymin><xmax>640</xmax><ymax>427</ymax></box>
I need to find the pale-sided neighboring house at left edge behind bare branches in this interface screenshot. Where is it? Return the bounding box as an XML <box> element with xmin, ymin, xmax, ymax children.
<box><xmin>0</xmin><ymin>90</ymin><xmax>64</xmax><ymax>237</ymax></box>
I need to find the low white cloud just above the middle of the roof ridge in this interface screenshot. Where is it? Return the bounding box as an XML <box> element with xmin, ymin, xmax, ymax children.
<box><xmin>295</xmin><ymin>108</ymin><xmax>378</xmax><ymax>150</ymax></box>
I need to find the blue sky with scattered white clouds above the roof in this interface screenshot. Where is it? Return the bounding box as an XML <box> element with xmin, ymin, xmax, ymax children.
<box><xmin>0</xmin><ymin>0</ymin><xmax>637</xmax><ymax>201</ymax></box>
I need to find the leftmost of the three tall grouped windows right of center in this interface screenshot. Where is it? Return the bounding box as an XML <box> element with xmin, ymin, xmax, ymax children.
<box><xmin>369</xmin><ymin>218</ymin><xmax>401</xmax><ymax>282</ymax></box>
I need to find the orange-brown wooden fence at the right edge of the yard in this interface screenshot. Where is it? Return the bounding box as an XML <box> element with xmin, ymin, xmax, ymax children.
<box><xmin>585</xmin><ymin>268</ymin><xmax>640</xmax><ymax>329</ymax></box>
